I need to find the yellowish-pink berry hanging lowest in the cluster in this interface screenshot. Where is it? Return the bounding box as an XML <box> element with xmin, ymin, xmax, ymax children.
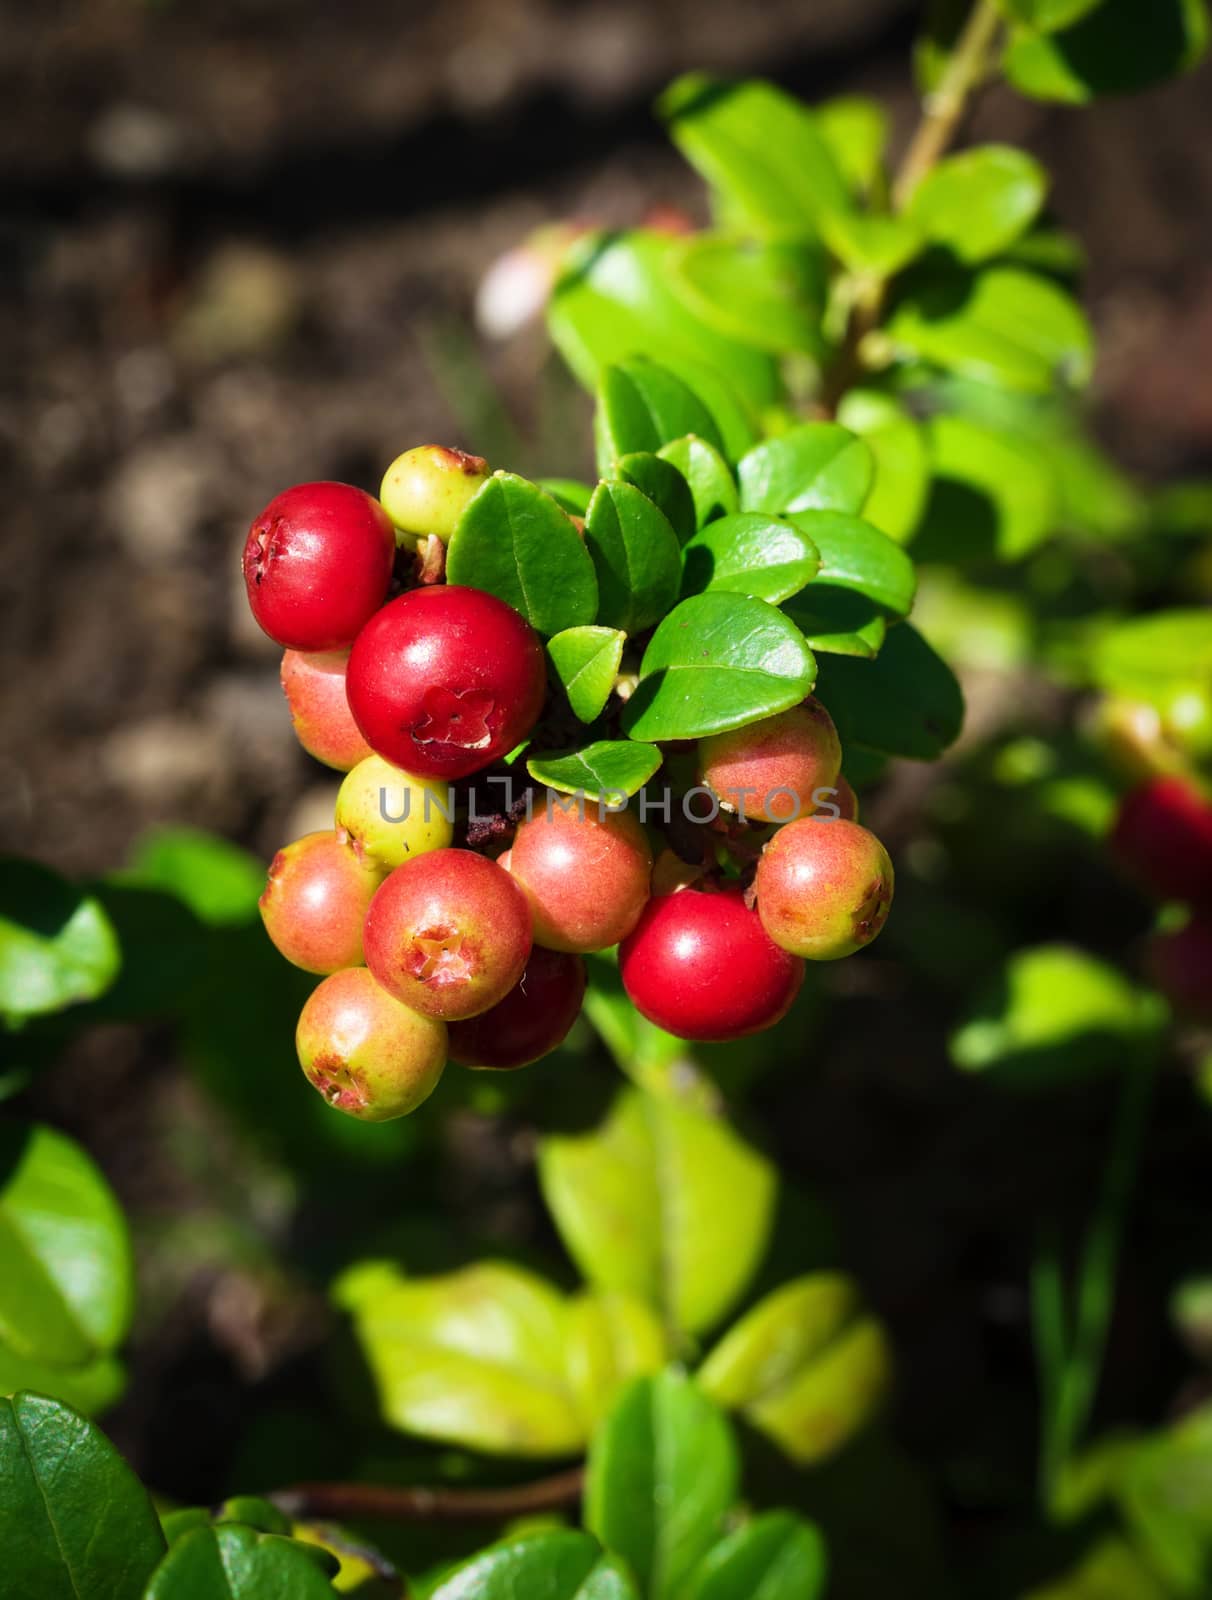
<box><xmin>294</xmin><ymin>966</ymin><xmax>446</xmax><ymax>1122</ymax></box>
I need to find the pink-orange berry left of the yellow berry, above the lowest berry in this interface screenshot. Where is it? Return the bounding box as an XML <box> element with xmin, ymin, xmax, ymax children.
<box><xmin>257</xmin><ymin>832</ymin><xmax>384</xmax><ymax>973</ymax></box>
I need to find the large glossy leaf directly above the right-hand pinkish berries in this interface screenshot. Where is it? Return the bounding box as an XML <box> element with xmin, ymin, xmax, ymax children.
<box><xmin>624</xmin><ymin>594</ymin><xmax>815</xmax><ymax>741</ymax></box>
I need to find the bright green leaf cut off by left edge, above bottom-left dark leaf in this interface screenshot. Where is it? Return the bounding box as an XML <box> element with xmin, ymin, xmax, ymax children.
<box><xmin>0</xmin><ymin>1122</ymin><xmax>134</xmax><ymax>1370</ymax></box>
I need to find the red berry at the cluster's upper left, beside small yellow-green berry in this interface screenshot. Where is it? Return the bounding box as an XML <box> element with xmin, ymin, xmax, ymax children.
<box><xmin>245</xmin><ymin>483</ymin><xmax>395</xmax><ymax>650</ymax></box>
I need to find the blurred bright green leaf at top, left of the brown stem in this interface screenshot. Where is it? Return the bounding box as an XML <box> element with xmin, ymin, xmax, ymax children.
<box><xmin>657</xmin><ymin>72</ymin><xmax>849</xmax><ymax>238</ymax></box>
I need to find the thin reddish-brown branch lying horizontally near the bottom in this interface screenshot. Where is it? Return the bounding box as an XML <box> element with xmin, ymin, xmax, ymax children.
<box><xmin>269</xmin><ymin>1467</ymin><xmax>585</xmax><ymax>1522</ymax></box>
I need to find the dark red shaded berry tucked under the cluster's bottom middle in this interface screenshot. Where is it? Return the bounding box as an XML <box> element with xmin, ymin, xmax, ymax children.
<box><xmin>449</xmin><ymin>944</ymin><xmax>585</xmax><ymax>1070</ymax></box>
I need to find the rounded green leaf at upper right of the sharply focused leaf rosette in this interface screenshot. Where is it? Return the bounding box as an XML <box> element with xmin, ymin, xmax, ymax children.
<box><xmin>737</xmin><ymin>422</ymin><xmax>875</xmax><ymax>512</ymax></box>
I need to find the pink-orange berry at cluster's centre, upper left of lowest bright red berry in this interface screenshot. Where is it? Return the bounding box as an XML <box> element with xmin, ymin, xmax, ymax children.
<box><xmin>508</xmin><ymin>792</ymin><xmax>652</xmax><ymax>954</ymax></box>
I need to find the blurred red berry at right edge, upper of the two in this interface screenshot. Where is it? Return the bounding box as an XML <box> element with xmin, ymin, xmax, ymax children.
<box><xmin>1111</xmin><ymin>778</ymin><xmax>1212</xmax><ymax>906</ymax></box>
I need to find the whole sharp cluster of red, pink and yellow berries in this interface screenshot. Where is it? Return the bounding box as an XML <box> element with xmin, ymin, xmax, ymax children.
<box><xmin>243</xmin><ymin>446</ymin><xmax>892</xmax><ymax>1120</ymax></box>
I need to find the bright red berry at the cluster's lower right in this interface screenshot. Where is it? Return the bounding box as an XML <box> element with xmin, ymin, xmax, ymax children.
<box><xmin>619</xmin><ymin>888</ymin><xmax>804</xmax><ymax>1040</ymax></box>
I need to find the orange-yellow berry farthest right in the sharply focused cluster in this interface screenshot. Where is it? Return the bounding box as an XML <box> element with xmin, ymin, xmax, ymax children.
<box><xmin>753</xmin><ymin>818</ymin><xmax>892</xmax><ymax>962</ymax></box>
